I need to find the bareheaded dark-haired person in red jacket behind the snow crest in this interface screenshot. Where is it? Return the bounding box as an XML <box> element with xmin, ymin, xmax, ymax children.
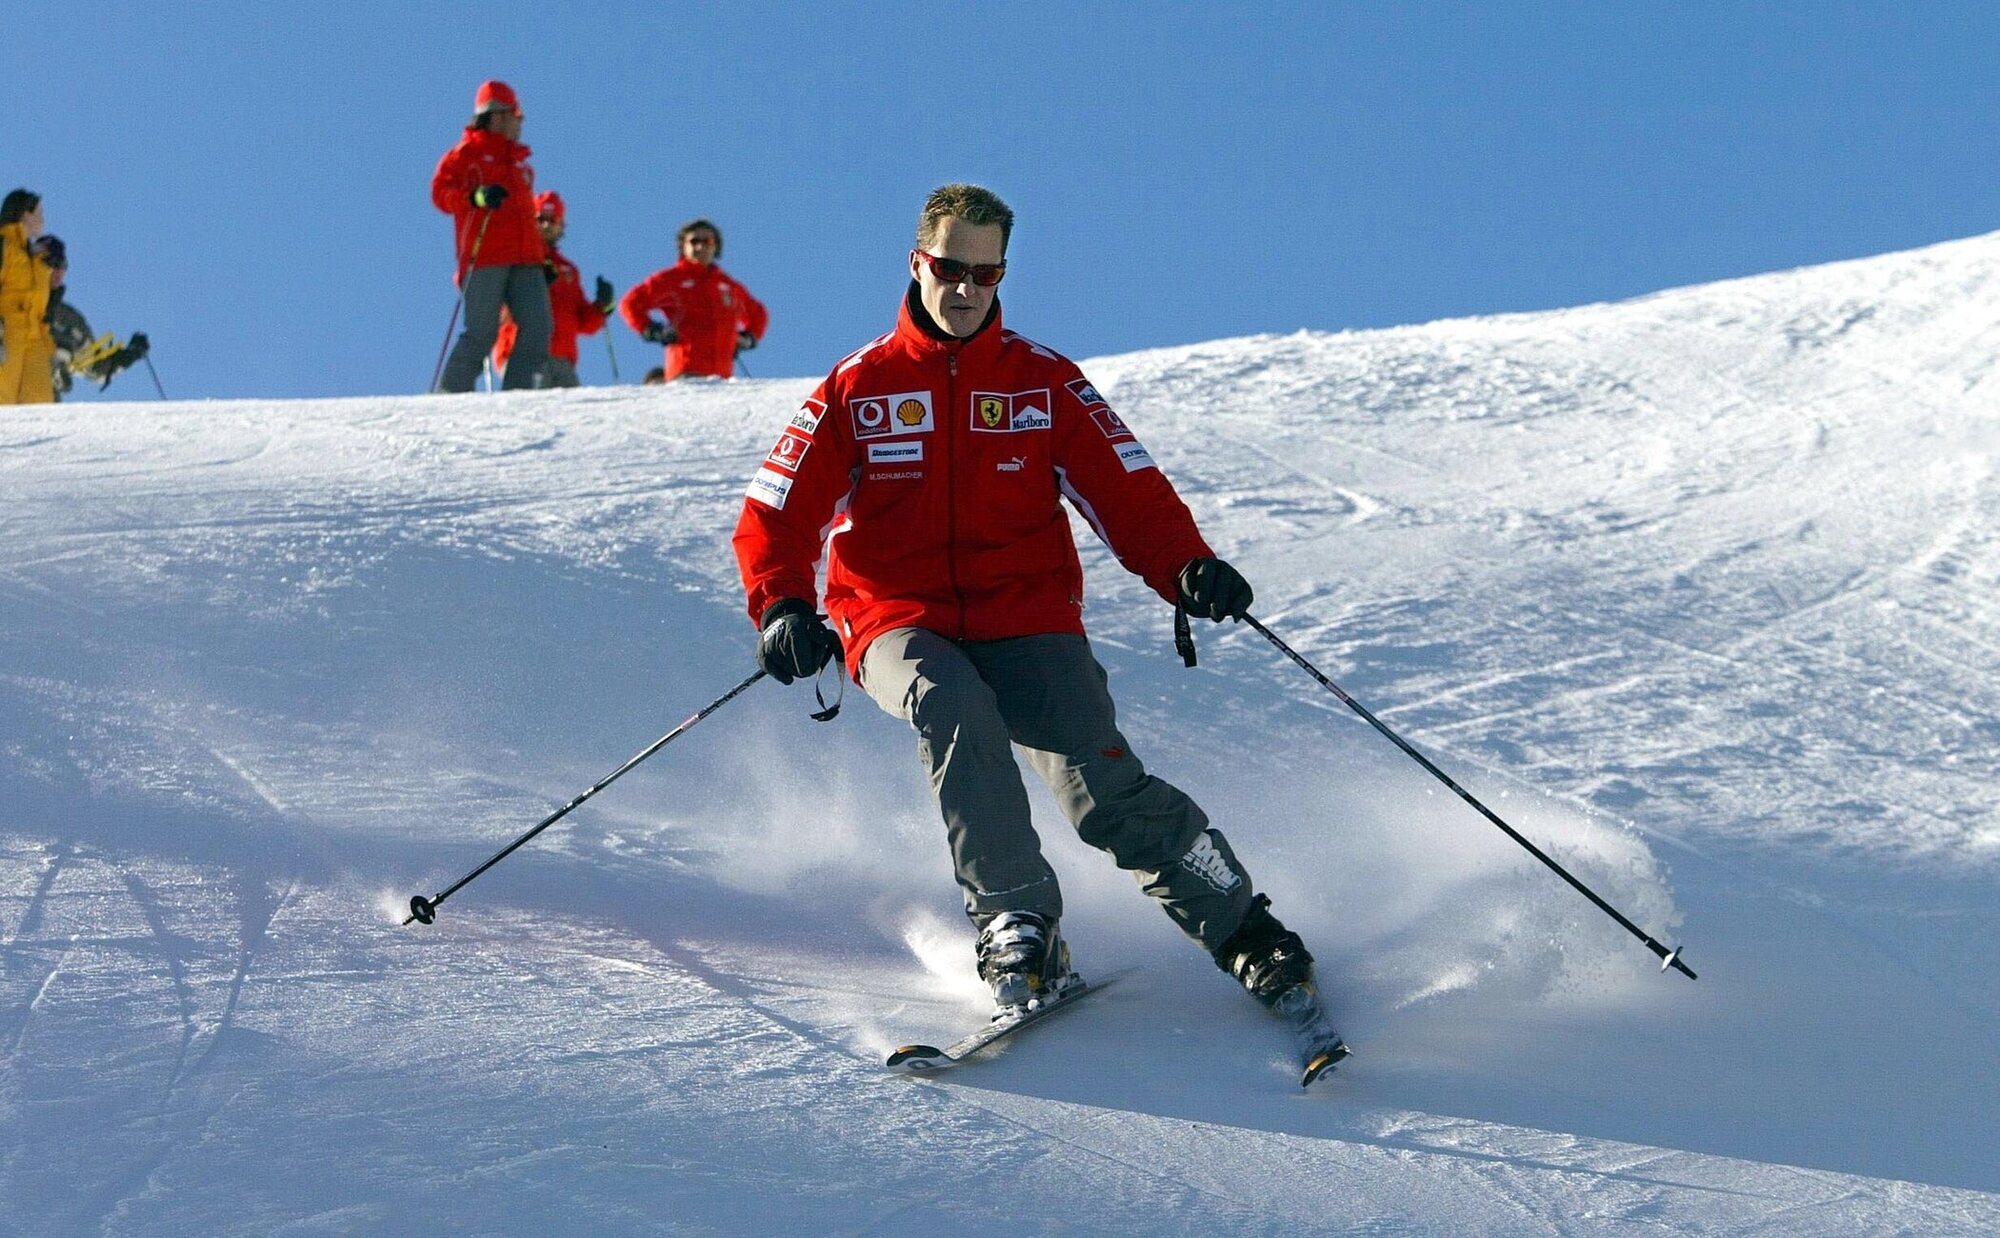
<box><xmin>618</xmin><ymin>220</ymin><xmax>770</xmax><ymax>382</ymax></box>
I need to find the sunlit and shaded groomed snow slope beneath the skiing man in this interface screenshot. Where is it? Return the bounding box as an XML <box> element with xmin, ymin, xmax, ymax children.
<box><xmin>11</xmin><ymin>236</ymin><xmax>2000</xmax><ymax>1234</ymax></box>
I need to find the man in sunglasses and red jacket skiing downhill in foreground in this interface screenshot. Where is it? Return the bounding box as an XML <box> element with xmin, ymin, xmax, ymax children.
<box><xmin>734</xmin><ymin>184</ymin><xmax>1344</xmax><ymax>1070</ymax></box>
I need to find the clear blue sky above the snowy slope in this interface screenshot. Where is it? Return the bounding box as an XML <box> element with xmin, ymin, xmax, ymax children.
<box><xmin>0</xmin><ymin>0</ymin><xmax>2000</xmax><ymax>398</ymax></box>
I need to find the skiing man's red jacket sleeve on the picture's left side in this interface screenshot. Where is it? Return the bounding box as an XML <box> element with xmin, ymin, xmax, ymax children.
<box><xmin>732</xmin><ymin>378</ymin><xmax>860</xmax><ymax>622</ymax></box>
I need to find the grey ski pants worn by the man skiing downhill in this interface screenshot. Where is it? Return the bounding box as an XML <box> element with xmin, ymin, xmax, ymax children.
<box><xmin>860</xmin><ymin>628</ymin><xmax>1250</xmax><ymax>950</ymax></box>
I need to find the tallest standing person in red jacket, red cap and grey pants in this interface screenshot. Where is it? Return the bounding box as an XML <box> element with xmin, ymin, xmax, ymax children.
<box><xmin>430</xmin><ymin>82</ymin><xmax>550</xmax><ymax>392</ymax></box>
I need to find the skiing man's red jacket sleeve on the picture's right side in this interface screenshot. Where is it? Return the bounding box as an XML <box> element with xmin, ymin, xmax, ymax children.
<box><xmin>1050</xmin><ymin>364</ymin><xmax>1214</xmax><ymax>602</ymax></box>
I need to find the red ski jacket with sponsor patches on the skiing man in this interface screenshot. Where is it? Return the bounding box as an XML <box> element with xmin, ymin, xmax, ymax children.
<box><xmin>734</xmin><ymin>282</ymin><xmax>1214</xmax><ymax>674</ymax></box>
